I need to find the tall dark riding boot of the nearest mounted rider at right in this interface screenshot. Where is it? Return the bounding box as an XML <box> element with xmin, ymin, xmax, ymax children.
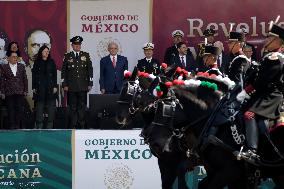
<box><xmin>242</xmin><ymin>112</ymin><xmax>259</xmax><ymax>159</ymax></box>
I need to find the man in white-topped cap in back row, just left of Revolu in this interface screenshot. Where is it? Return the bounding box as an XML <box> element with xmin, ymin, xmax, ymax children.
<box><xmin>164</xmin><ymin>30</ymin><xmax>184</xmax><ymax>64</ymax></box>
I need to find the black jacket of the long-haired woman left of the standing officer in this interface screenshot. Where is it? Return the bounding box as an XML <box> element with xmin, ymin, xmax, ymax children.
<box><xmin>32</xmin><ymin>59</ymin><xmax>57</xmax><ymax>101</ymax></box>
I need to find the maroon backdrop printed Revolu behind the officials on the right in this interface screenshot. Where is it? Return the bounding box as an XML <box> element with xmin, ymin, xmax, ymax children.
<box><xmin>153</xmin><ymin>0</ymin><xmax>284</xmax><ymax>60</ymax></box>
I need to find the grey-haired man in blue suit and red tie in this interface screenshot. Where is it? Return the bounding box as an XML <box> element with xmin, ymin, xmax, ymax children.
<box><xmin>100</xmin><ymin>42</ymin><xmax>128</xmax><ymax>94</ymax></box>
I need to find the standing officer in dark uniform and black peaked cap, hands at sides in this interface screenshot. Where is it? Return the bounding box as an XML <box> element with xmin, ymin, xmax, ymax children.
<box><xmin>61</xmin><ymin>36</ymin><xmax>93</xmax><ymax>128</ymax></box>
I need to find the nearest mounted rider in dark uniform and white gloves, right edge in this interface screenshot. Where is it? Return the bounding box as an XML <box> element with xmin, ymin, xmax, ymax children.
<box><xmin>237</xmin><ymin>24</ymin><xmax>284</xmax><ymax>158</ymax></box>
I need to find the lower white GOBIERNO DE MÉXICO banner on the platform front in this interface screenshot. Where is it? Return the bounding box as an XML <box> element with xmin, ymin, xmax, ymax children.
<box><xmin>74</xmin><ymin>130</ymin><xmax>161</xmax><ymax>189</ymax></box>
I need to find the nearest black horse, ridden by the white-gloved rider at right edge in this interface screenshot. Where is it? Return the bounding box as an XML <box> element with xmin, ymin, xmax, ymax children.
<box><xmin>133</xmin><ymin>75</ymin><xmax>284</xmax><ymax>189</ymax></box>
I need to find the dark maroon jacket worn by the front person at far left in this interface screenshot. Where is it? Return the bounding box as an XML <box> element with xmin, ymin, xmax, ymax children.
<box><xmin>1</xmin><ymin>63</ymin><xmax>28</xmax><ymax>96</ymax></box>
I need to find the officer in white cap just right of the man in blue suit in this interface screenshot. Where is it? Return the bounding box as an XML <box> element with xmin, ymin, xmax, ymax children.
<box><xmin>137</xmin><ymin>43</ymin><xmax>160</xmax><ymax>75</ymax></box>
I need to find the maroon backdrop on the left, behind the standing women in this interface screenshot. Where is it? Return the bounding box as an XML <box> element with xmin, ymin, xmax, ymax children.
<box><xmin>0</xmin><ymin>0</ymin><xmax>67</xmax><ymax>69</ymax></box>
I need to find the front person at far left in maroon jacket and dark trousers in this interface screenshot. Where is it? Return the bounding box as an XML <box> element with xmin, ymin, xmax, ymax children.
<box><xmin>1</xmin><ymin>51</ymin><xmax>28</xmax><ymax>129</ymax></box>
